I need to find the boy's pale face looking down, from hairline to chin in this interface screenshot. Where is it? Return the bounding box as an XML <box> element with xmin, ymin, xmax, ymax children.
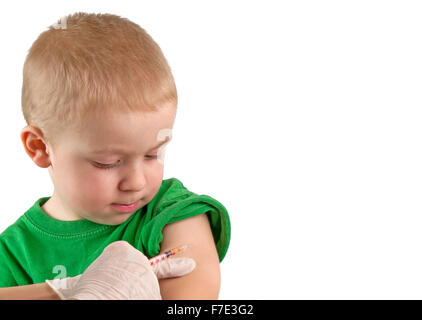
<box><xmin>43</xmin><ymin>104</ymin><xmax>176</xmax><ymax>225</ymax></box>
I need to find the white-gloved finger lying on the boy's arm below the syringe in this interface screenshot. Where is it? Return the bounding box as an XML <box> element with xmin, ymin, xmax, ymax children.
<box><xmin>152</xmin><ymin>258</ymin><xmax>196</xmax><ymax>279</ymax></box>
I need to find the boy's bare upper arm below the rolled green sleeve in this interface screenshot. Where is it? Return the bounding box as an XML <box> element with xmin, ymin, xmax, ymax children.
<box><xmin>159</xmin><ymin>213</ymin><xmax>220</xmax><ymax>300</ymax></box>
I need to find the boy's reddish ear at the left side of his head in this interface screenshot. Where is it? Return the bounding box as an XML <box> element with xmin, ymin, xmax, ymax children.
<box><xmin>21</xmin><ymin>125</ymin><xmax>51</xmax><ymax>168</ymax></box>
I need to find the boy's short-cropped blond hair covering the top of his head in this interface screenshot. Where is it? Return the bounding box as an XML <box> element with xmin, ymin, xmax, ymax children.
<box><xmin>22</xmin><ymin>12</ymin><xmax>177</xmax><ymax>145</ymax></box>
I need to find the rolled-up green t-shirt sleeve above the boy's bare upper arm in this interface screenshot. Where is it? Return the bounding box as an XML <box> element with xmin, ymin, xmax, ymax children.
<box><xmin>140</xmin><ymin>178</ymin><xmax>230</xmax><ymax>262</ymax></box>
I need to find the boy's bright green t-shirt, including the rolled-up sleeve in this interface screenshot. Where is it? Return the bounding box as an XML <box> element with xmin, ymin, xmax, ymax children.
<box><xmin>0</xmin><ymin>178</ymin><xmax>230</xmax><ymax>287</ymax></box>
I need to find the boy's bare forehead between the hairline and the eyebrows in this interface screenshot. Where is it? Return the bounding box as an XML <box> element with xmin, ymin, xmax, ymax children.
<box><xmin>72</xmin><ymin>109</ymin><xmax>175</xmax><ymax>152</ymax></box>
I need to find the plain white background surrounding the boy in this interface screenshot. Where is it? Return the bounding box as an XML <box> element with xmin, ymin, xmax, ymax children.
<box><xmin>0</xmin><ymin>0</ymin><xmax>422</xmax><ymax>299</ymax></box>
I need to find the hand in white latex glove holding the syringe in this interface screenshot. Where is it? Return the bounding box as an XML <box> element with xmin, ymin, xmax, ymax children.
<box><xmin>46</xmin><ymin>241</ymin><xmax>195</xmax><ymax>300</ymax></box>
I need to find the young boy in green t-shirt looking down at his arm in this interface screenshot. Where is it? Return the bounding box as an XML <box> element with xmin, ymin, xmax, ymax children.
<box><xmin>0</xmin><ymin>13</ymin><xmax>230</xmax><ymax>299</ymax></box>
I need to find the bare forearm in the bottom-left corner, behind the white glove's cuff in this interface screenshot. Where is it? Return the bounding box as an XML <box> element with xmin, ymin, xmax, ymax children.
<box><xmin>0</xmin><ymin>282</ymin><xmax>60</xmax><ymax>300</ymax></box>
